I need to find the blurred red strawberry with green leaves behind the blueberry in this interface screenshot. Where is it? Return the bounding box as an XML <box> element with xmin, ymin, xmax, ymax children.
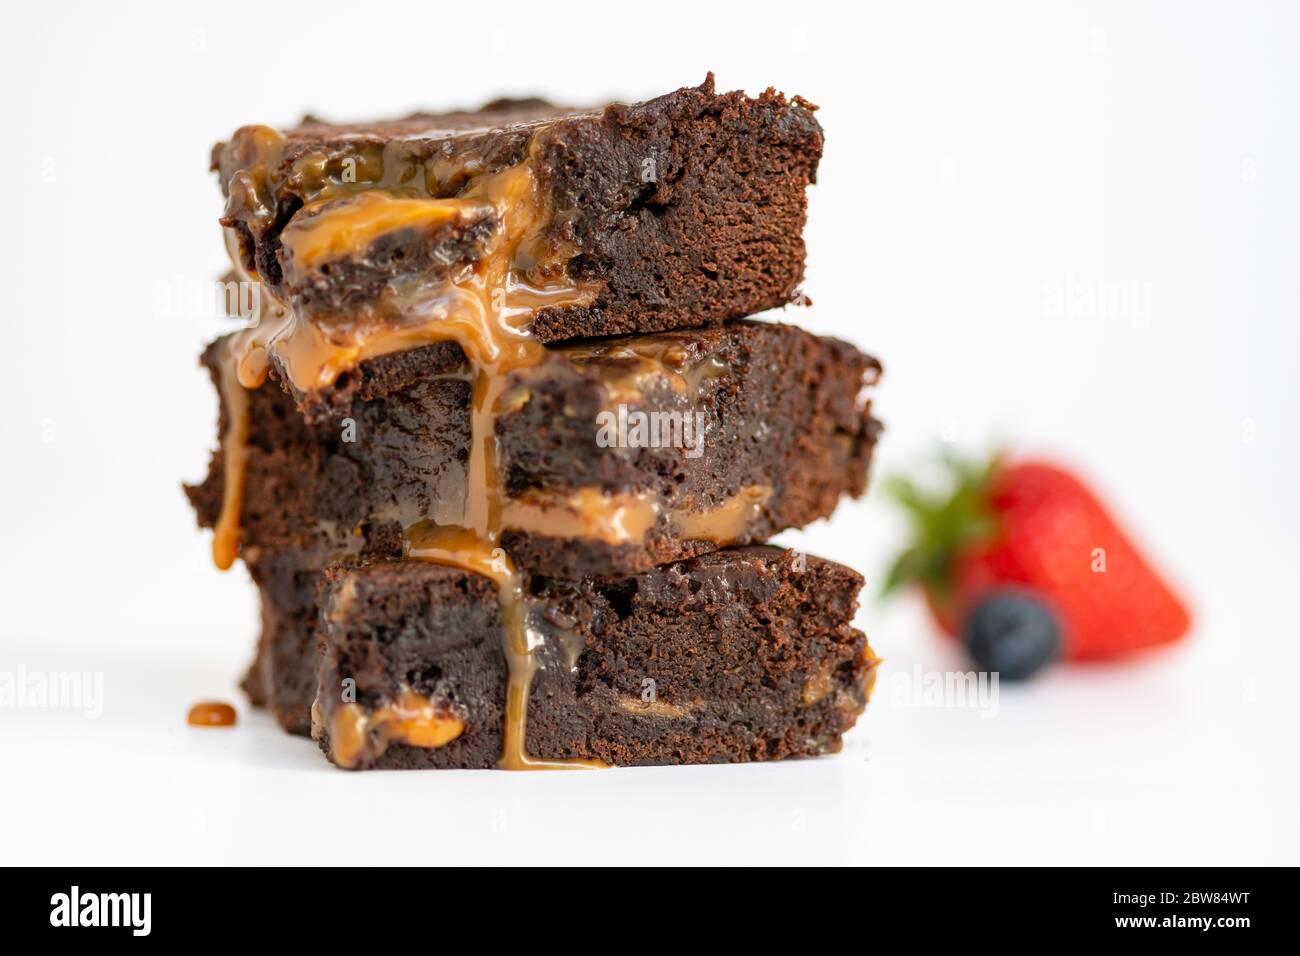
<box><xmin>885</xmin><ymin>458</ymin><xmax>1190</xmax><ymax>661</ymax></box>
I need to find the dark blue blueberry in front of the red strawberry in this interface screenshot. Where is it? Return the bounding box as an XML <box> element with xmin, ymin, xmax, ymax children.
<box><xmin>962</xmin><ymin>591</ymin><xmax>1061</xmax><ymax>680</ymax></box>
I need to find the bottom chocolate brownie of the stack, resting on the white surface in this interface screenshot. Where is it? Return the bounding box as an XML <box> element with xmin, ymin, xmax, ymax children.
<box><xmin>312</xmin><ymin>546</ymin><xmax>876</xmax><ymax>769</ymax></box>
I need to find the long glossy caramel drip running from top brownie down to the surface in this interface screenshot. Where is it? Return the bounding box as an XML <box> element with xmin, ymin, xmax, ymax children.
<box><xmin>224</xmin><ymin>130</ymin><xmax>597</xmax><ymax>769</ymax></box>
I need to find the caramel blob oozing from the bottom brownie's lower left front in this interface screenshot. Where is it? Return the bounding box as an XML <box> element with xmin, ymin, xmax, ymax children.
<box><xmin>330</xmin><ymin>688</ymin><xmax>465</xmax><ymax>767</ymax></box>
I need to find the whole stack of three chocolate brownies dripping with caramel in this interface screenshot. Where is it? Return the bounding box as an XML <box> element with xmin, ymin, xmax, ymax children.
<box><xmin>187</xmin><ymin>77</ymin><xmax>880</xmax><ymax>769</ymax></box>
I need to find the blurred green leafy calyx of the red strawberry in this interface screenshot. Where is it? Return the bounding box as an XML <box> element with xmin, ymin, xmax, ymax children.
<box><xmin>881</xmin><ymin>453</ymin><xmax>1001</xmax><ymax>604</ymax></box>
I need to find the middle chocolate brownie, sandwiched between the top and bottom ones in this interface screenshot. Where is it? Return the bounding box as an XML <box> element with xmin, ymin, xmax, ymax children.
<box><xmin>187</xmin><ymin>321</ymin><xmax>880</xmax><ymax>578</ymax></box>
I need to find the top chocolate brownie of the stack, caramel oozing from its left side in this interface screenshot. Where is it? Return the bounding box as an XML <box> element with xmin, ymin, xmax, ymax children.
<box><xmin>213</xmin><ymin>74</ymin><xmax>823</xmax><ymax>356</ymax></box>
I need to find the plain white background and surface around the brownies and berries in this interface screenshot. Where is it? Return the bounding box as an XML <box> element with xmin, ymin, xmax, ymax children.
<box><xmin>0</xmin><ymin>0</ymin><xmax>1300</xmax><ymax>865</ymax></box>
